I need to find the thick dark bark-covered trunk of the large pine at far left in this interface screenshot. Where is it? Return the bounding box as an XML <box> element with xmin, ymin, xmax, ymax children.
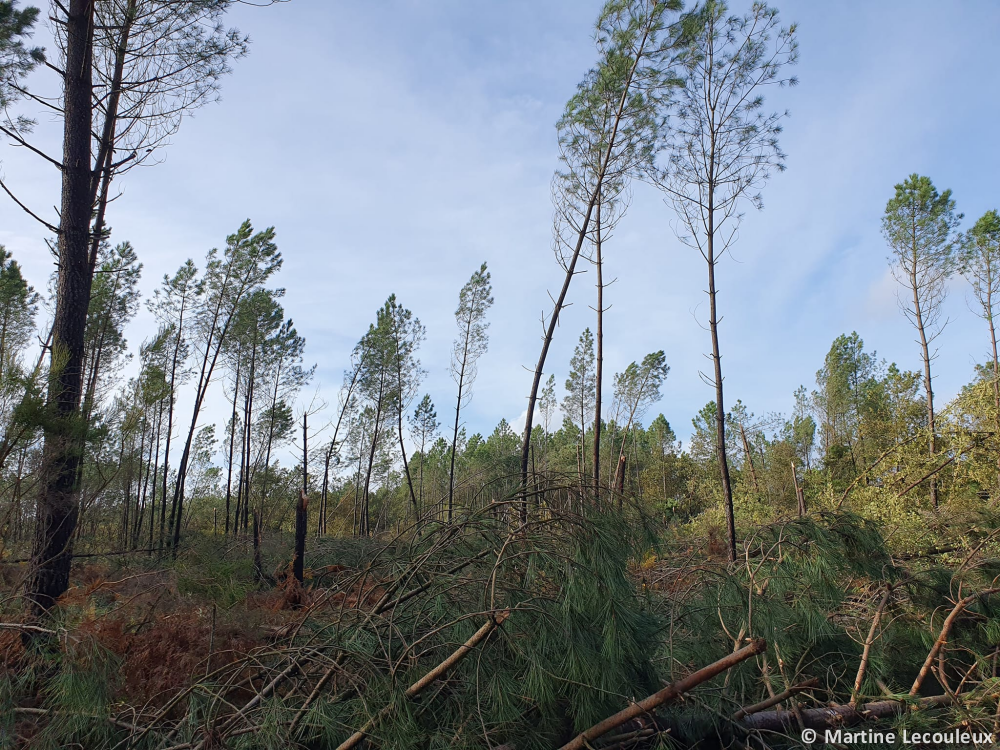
<box><xmin>26</xmin><ymin>0</ymin><xmax>94</xmax><ymax>615</ymax></box>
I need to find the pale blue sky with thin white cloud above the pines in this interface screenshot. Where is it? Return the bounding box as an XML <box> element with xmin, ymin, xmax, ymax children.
<box><xmin>0</xmin><ymin>0</ymin><xmax>1000</xmax><ymax>452</ymax></box>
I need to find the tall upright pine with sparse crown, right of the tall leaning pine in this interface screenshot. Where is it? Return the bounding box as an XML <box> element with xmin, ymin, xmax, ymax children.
<box><xmin>656</xmin><ymin>0</ymin><xmax>798</xmax><ymax>562</ymax></box>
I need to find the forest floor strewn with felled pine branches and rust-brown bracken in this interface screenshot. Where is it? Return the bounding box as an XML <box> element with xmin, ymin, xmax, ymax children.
<box><xmin>0</xmin><ymin>514</ymin><xmax>1000</xmax><ymax>750</ymax></box>
